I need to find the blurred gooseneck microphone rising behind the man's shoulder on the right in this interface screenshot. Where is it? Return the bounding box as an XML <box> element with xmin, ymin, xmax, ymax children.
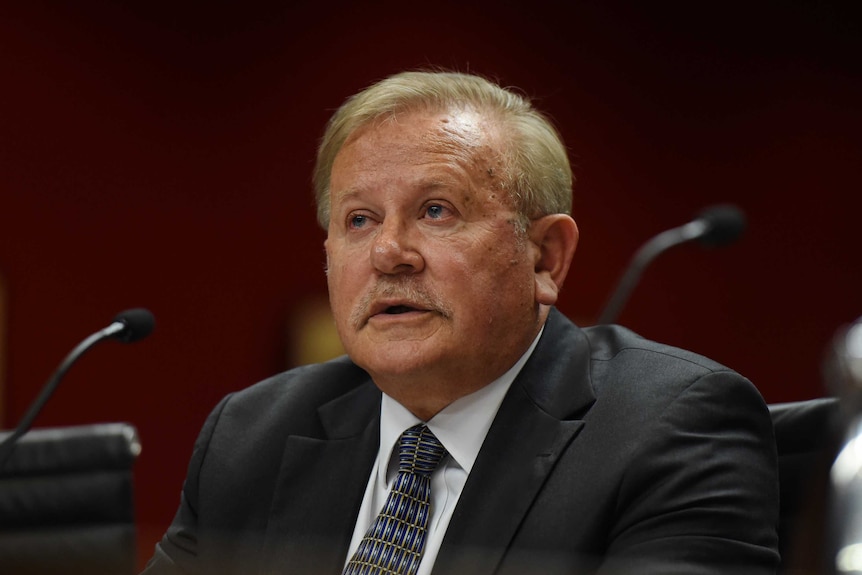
<box><xmin>597</xmin><ymin>204</ymin><xmax>746</xmax><ymax>324</ymax></box>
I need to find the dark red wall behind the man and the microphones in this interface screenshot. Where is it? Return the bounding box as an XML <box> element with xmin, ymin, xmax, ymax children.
<box><xmin>0</xmin><ymin>0</ymin><xmax>862</xmax><ymax>560</ymax></box>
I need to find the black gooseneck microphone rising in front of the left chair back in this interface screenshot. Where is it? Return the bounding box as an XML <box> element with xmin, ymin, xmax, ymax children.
<box><xmin>0</xmin><ymin>308</ymin><xmax>156</xmax><ymax>471</ymax></box>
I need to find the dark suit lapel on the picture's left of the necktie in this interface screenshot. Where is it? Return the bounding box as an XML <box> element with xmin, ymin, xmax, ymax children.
<box><xmin>263</xmin><ymin>380</ymin><xmax>380</xmax><ymax>575</ymax></box>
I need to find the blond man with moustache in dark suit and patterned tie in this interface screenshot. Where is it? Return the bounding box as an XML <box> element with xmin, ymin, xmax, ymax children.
<box><xmin>146</xmin><ymin>72</ymin><xmax>778</xmax><ymax>575</ymax></box>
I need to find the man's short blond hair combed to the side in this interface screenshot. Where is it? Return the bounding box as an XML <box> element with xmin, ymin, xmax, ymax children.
<box><xmin>313</xmin><ymin>72</ymin><xmax>573</xmax><ymax>229</ymax></box>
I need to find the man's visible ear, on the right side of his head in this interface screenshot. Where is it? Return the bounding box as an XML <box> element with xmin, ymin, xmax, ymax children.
<box><xmin>527</xmin><ymin>214</ymin><xmax>579</xmax><ymax>305</ymax></box>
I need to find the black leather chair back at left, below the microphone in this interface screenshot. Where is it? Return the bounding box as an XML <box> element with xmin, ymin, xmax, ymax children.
<box><xmin>0</xmin><ymin>423</ymin><xmax>140</xmax><ymax>575</ymax></box>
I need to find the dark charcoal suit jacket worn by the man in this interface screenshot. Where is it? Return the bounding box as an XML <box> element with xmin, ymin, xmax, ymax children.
<box><xmin>145</xmin><ymin>310</ymin><xmax>778</xmax><ymax>575</ymax></box>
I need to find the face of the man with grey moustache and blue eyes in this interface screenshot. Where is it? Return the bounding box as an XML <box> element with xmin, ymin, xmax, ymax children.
<box><xmin>326</xmin><ymin>111</ymin><xmax>540</xmax><ymax>414</ymax></box>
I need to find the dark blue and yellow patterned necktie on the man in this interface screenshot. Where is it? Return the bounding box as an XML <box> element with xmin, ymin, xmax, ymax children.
<box><xmin>343</xmin><ymin>424</ymin><xmax>446</xmax><ymax>575</ymax></box>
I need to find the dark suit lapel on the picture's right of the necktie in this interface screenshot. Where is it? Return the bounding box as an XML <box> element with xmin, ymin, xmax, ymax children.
<box><xmin>434</xmin><ymin>310</ymin><xmax>595</xmax><ymax>575</ymax></box>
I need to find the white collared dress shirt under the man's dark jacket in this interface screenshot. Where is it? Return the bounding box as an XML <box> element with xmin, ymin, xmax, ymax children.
<box><xmin>345</xmin><ymin>328</ymin><xmax>544</xmax><ymax>575</ymax></box>
